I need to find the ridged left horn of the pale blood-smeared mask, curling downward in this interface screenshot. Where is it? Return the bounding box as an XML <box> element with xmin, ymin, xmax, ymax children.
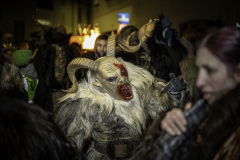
<box><xmin>63</xmin><ymin>58</ymin><xmax>98</xmax><ymax>93</ymax></box>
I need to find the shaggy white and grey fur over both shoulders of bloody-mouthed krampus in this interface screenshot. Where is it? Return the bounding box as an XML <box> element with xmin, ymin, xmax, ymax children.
<box><xmin>55</xmin><ymin>59</ymin><xmax>157</xmax><ymax>148</ymax></box>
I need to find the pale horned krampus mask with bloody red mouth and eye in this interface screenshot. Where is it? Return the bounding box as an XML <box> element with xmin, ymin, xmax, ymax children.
<box><xmin>66</xmin><ymin>35</ymin><xmax>141</xmax><ymax>100</ymax></box>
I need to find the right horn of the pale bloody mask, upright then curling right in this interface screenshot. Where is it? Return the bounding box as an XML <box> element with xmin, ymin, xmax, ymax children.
<box><xmin>107</xmin><ymin>34</ymin><xmax>141</xmax><ymax>57</ymax></box>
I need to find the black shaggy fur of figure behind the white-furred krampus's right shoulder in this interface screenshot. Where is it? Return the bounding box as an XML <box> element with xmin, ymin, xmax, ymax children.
<box><xmin>146</xmin><ymin>14</ymin><xmax>188</xmax><ymax>81</ymax></box>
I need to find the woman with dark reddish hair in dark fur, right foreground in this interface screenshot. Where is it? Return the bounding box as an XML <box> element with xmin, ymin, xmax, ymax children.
<box><xmin>137</xmin><ymin>27</ymin><xmax>240</xmax><ymax>160</ymax></box>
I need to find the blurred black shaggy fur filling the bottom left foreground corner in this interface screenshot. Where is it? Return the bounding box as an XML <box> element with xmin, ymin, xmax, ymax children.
<box><xmin>0</xmin><ymin>97</ymin><xmax>83</xmax><ymax>160</ymax></box>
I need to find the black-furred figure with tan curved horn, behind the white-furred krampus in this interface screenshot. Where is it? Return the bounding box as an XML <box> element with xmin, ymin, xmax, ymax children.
<box><xmin>118</xmin><ymin>14</ymin><xmax>188</xmax><ymax>81</ymax></box>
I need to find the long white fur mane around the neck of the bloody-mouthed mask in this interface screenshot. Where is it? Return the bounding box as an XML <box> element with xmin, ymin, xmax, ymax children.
<box><xmin>60</xmin><ymin>59</ymin><xmax>154</xmax><ymax>137</ymax></box>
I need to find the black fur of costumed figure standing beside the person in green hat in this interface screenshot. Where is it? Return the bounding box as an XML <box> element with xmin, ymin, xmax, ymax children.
<box><xmin>33</xmin><ymin>31</ymin><xmax>80</xmax><ymax>111</ymax></box>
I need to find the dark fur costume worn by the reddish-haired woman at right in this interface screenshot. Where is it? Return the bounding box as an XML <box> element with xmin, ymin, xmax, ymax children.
<box><xmin>137</xmin><ymin>84</ymin><xmax>240</xmax><ymax>160</ymax></box>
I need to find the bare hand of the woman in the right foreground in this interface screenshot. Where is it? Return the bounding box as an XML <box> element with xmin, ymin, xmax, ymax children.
<box><xmin>161</xmin><ymin>103</ymin><xmax>192</xmax><ymax>136</ymax></box>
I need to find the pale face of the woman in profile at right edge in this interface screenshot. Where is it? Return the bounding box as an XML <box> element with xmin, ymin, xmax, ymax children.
<box><xmin>196</xmin><ymin>48</ymin><xmax>239</xmax><ymax>104</ymax></box>
